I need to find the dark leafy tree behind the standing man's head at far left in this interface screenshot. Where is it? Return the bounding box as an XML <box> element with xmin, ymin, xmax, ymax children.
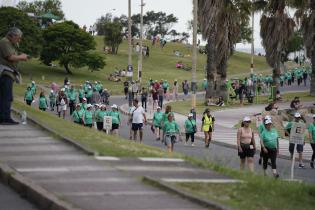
<box><xmin>0</xmin><ymin>7</ymin><xmax>42</xmax><ymax>57</ymax></box>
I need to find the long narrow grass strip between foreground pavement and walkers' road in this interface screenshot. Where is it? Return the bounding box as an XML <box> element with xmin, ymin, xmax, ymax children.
<box><xmin>14</xmin><ymin>100</ymin><xmax>179</xmax><ymax>157</ymax></box>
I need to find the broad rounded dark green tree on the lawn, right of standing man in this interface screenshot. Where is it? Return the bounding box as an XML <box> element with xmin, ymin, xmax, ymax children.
<box><xmin>40</xmin><ymin>21</ymin><xmax>105</xmax><ymax>74</ymax></box>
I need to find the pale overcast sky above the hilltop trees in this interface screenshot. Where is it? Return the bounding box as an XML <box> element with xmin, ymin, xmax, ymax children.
<box><xmin>8</xmin><ymin>0</ymin><xmax>261</xmax><ymax>48</ymax></box>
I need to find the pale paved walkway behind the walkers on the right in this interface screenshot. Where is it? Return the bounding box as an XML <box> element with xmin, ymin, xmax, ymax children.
<box><xmin>120</xmin><ymin>101</ymin><xmax>314</xmax><ymax>160</ymax></box>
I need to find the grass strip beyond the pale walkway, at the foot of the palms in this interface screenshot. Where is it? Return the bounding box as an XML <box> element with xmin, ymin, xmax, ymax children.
<box><xmin>169</xmin><ymin>92</ymin><xmax>315</xmax><ymax>114</ymax></box>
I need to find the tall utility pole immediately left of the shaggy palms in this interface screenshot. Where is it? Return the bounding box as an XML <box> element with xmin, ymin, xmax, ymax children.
<box><xmin>191</xmin><ymin>0</ymin><xmax>198</xmax><ymax>112</ymax></box>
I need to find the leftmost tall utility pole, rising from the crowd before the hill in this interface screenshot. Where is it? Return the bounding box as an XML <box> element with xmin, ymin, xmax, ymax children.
<box><xmin>127</xmin><ymin>0</ymin><xmax>133</xmax><ymax>107</ymax></box>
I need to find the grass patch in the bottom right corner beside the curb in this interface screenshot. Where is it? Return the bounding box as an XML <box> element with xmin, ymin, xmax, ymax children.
<box><xmin>176</xmin><ymin>178</ymin><xmax>315</xmax><ymax>210</ymax></box>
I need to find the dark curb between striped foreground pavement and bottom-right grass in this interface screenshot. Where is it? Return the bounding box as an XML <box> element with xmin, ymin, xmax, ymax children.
<box><xmin>142</xmin><ymin>176</ymin><xmax>233</xmax><ymax>210</ymax></box>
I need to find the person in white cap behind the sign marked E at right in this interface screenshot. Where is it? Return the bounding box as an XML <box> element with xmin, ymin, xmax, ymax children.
<box><xmin>285</xmin><ymin>112</ymin><xmax>305</xmax><ymax>168</ymax></box>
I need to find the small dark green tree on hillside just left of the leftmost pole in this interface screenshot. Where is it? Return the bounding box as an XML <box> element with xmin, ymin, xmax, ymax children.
<box><xmin>103</xmin><ymin>22</ymin><xmax>123</xmax><ymax>54</ymax></box>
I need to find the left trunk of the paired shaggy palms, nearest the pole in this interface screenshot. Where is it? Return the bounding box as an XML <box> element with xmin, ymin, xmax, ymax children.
<box><xmin>205</xmin><ymin>29</ymin><xmax>216</xmax><ymax>101</ymax></box>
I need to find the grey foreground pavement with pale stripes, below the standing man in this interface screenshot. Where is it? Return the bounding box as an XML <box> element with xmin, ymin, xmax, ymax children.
<box><xmin>0</xmin><ymin>121</ymin><xmax>237</xmax><ymax>210</ymax></box>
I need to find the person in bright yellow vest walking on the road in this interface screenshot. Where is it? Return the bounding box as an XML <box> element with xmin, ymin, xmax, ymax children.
<box><xmin>201</xmin><ymin>109</ymin><xmax>215</xmax><ymax>148</ymax></box>
